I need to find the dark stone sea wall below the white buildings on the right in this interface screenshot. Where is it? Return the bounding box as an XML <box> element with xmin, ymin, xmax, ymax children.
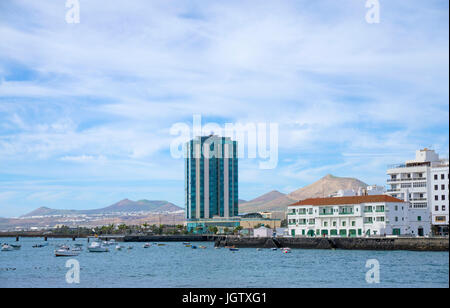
<box><xmin>215</xmin><ymin>237</ymin><xmax>449</xmax><ymax>251</ymax></box>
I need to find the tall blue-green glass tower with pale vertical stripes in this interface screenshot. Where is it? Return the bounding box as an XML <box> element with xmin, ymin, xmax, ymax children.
<box><xmin>185</xmin><ymin>135</ymin><xmax>239</xmax><ymax>221</ymax></box>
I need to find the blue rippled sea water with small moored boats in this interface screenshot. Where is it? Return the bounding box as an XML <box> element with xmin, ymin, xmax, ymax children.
<box><xmin>0</xmin><ymin>238</ymin><xmax>449</xmax><ymax>288</ymax></box>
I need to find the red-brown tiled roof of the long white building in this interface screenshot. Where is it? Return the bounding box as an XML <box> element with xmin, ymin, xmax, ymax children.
<box><xmin>289</xmin><ymin>195</ymin><xmax>404</xmax><ymax>206</ymax></box>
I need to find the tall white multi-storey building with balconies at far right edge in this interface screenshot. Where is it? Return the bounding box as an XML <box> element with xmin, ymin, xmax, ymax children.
<box><xmin>387</xmin><ymin>148</ymin><xmax>449</xmax><ymax>235</ymax></box>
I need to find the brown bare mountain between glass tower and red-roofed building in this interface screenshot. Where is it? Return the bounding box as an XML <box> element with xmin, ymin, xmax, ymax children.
<box><xmin>239</xmin><ymin>174</ymin><xmax>367</xmax><ymax>213</ymax></box>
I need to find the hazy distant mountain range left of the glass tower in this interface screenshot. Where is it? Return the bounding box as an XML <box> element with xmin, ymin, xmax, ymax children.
<box><xmin>21</xmin><ymin>199</ymin><xmax>183</xmax><ymax>218</ymax></box>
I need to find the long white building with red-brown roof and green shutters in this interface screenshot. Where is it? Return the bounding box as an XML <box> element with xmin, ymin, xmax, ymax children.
<box><xmin>287</xmin><ymin>195</ymin><xmax>412</xmax><ymax>237</ymax></box>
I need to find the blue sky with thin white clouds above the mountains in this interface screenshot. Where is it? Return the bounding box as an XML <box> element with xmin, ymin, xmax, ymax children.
<box><xmin>0</xmin><ymin>0</ymin><xmax>449</xmax><ymax>217</ymax></box>
